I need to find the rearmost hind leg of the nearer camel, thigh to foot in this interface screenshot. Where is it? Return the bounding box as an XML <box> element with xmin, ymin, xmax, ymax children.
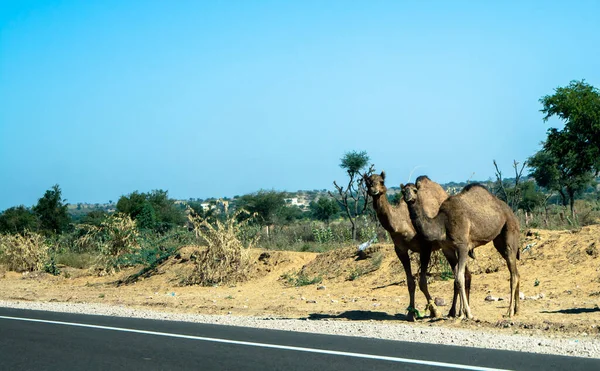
<box><xmin>494</xmin><ymin>227</ymin><xmax>520</xmax><ymax>317</ymax></box>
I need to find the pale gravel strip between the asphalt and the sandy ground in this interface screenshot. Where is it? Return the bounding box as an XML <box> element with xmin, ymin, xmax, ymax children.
<box><xmin>0</xmin><ymin>300</ymin><xmax>600</xmax><ymax>358</ymax></box>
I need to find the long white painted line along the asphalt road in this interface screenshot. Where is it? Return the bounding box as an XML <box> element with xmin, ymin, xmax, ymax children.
<box><xmin>0</xmin><ymin>316</ymin><xmax>509</xmax><ymax>371</ymax></box>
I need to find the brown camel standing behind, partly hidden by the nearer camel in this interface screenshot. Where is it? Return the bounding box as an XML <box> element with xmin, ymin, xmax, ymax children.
<box><xmin>363</xmin><ymin>171</ymin><xmax>471</xmax><ymax>321</ymax></box>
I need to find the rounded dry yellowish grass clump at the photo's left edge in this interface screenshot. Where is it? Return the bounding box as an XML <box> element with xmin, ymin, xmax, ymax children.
<box><xmin>0</xmin><ymin>231</ymin><xmax>48</xmax><ymax>272</ymax></box>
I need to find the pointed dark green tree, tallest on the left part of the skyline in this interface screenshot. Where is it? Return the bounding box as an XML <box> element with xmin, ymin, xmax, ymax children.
<box><xmin>33</xmin><ymin>184</ymin><xmax>71</xmax><ymax>234</ymax></box>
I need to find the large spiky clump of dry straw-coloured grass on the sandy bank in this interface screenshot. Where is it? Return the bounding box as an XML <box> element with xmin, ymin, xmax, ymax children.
<box><xmin>183</xmin><ymin>210</ymin><xmax>258</xmax><ymax>286</ymax></box>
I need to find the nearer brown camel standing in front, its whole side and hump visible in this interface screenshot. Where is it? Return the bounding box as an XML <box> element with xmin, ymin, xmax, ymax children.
<box><xmin>402</xmin><ymin>177</ymin><xmax>520</xmax><ymax>319</ymax></box>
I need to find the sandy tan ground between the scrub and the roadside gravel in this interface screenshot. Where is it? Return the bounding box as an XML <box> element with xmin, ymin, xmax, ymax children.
<box><xmin>0</xmin><ymin>225</ymin><xmax>600</xmax><ymax>339</ymax></box>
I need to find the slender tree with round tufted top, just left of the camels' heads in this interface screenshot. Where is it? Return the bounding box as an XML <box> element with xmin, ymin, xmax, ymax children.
<box><xmin>329</xmin><ymin>151</ymin><xmax>373</xmax><ymax>240</ymax></box>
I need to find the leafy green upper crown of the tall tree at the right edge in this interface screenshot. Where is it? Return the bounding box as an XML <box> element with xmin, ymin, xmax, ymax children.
<box><xmin>540</xmin><ymin>80</ymin><xmax>600</xmax><ymax>174</ymax></box>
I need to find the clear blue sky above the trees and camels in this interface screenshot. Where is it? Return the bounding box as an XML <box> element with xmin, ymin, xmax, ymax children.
<box><xmin>0</xmin><ymin>0</ymin><xmax>600</xmax><ymax>210</ymax></box>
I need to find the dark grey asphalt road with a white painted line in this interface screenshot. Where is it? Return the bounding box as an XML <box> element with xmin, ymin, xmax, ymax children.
<box><xmin>0</xmin><ymin>308</ymin><xmax>600</xmax><ymax>371</ymax></box>
